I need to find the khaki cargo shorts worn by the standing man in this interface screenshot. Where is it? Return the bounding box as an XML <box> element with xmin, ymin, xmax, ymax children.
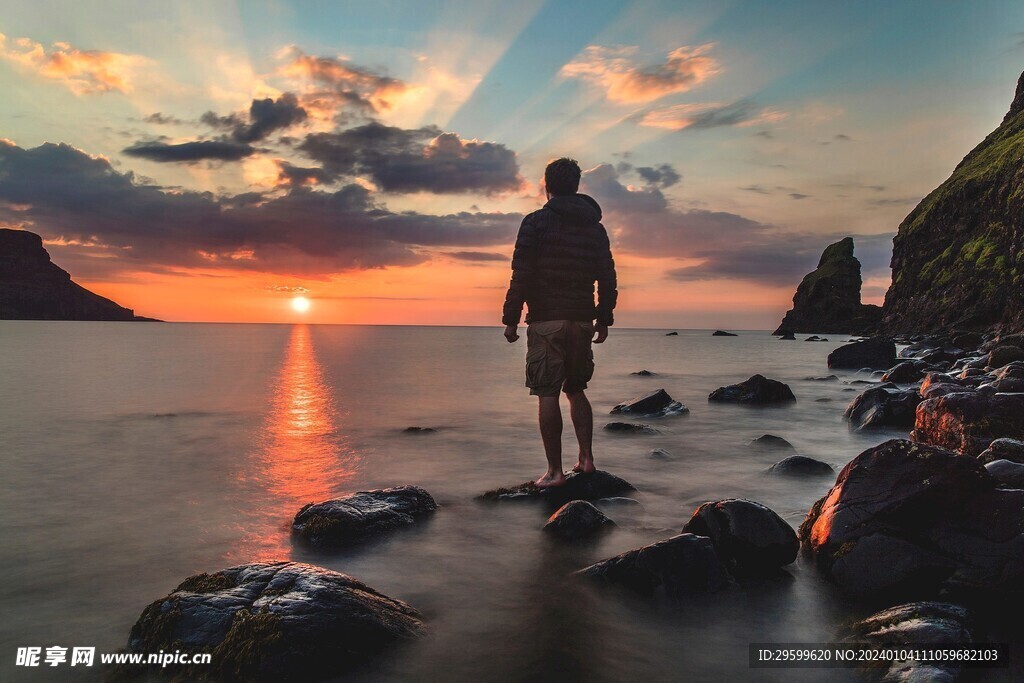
<box><xmin>526</xmin><ymin>321</ymin><xmax>594</xmax><ymax>396</ymax></box>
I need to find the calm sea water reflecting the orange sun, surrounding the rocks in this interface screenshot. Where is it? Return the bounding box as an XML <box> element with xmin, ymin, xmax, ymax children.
<box><xmin>0</xmin><ymin>322</ymin><xmax>1019</xmax><ymax>681</ymax></box>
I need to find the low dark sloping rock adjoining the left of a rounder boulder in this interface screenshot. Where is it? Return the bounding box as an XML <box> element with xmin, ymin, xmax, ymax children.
<box><xmin>575</xmin><ymin>533</ymin><xmax>731</xmax><ymax>599</ymax></box>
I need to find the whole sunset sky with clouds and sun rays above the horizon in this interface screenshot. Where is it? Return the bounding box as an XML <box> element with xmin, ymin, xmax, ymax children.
<box><xmin>0</xmin><ymin>0</ymin><xmax>1024</xmax><ymax>329</ymax></box>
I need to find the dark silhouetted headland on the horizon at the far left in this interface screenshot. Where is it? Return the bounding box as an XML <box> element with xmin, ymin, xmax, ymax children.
<box><xmin>0</xmin><ymin>228</ymin><xmax>148</xmax><ymax>321</ymax></box>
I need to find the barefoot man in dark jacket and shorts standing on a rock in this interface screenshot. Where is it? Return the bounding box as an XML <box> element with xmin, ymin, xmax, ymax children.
<box><xmin>502</xmin><ymin>159</ymin><xmax>618</xmax><ymax>488</ymax></box>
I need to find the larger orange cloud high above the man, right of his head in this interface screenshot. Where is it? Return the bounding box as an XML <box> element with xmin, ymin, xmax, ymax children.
<box><xmin>561</xmin><ymin>43</ymin><xmax>721</xmax><ymax>103</ymax></box>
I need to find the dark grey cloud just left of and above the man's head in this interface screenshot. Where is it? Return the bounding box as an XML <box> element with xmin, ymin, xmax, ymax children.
<box><xmin>298</xmin><ymin>122</ymin><xmax>521</xmax><ymax>194</ymax></box>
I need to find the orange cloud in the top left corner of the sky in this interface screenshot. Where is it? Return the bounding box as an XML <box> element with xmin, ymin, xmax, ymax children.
<box><xmin>0</xmin><ymin>34</ymin><xmax>148</xmax><ymax>95</ymax></box>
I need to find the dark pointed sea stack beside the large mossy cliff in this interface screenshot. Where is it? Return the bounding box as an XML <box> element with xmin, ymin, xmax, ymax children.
<box><xmin>775</xmin><ymin>238</ymin><xmax>882</xmax><ymax>335</ymax></box>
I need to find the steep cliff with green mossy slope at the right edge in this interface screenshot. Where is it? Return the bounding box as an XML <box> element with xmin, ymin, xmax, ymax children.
<box><xmin>883</xmin><ymin>75</ymin><xmax>1024</xmax><ymax>333</ymax></box>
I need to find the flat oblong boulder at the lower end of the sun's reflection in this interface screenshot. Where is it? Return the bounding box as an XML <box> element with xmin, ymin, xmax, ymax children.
<box><xmin>292</xmin><ymin>486</ymin><xmax>437</xmax><ymax>546</ymax></box>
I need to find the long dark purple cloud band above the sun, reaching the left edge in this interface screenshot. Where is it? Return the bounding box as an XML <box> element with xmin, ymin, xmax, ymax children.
<box><xmin>0</xmin><ymin>143</ymin><xmax>521</xmax><ymax>276</ymax></box>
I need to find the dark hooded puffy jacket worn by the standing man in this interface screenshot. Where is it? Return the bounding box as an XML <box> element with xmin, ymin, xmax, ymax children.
<box><xmin>502</xmin><ymin>195</ymin><xmax>618</xmax><ymax>325</ymax></box>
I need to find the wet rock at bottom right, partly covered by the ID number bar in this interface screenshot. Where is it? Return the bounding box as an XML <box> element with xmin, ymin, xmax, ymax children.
<box><xmin>848</xmin><ymin>602</ymin><xmax>972</xmax><ymax>683</ymax></box>
